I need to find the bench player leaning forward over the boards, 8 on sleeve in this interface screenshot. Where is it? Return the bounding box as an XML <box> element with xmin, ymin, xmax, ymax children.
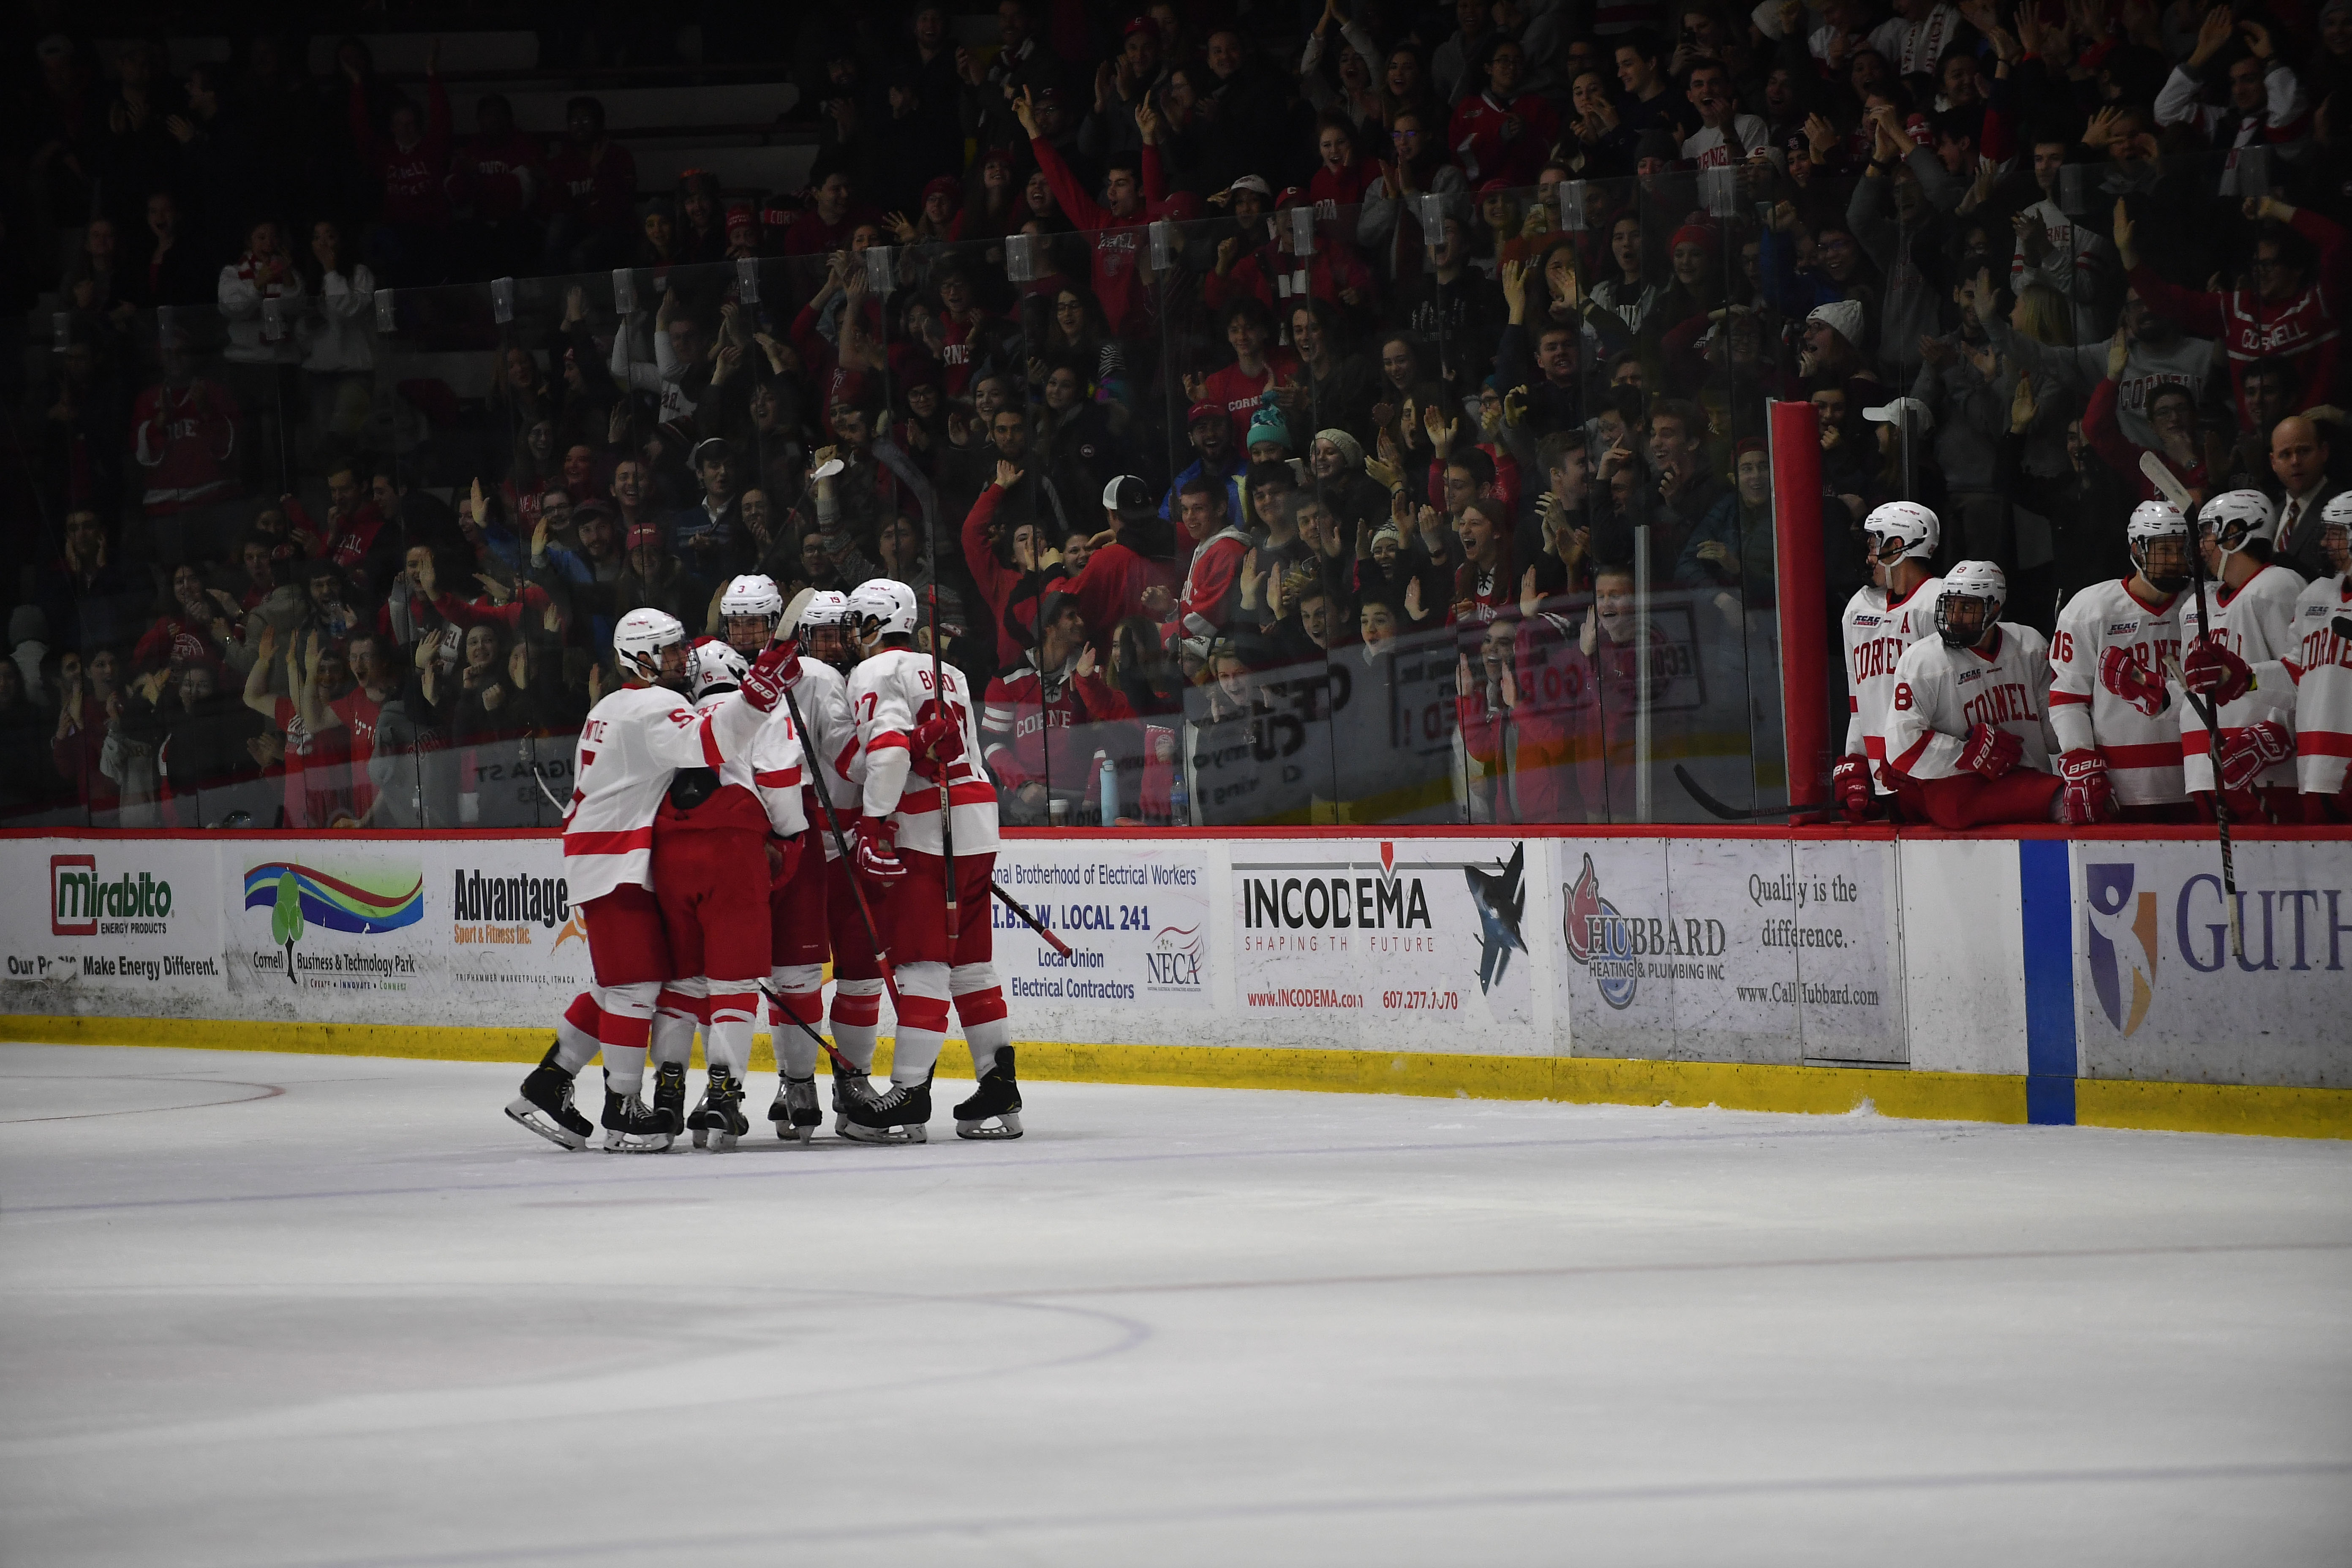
<box><xmin>1886</xmin><ymin>562</ymin><xmax>2058</xmax><ymax>828</ymax></box>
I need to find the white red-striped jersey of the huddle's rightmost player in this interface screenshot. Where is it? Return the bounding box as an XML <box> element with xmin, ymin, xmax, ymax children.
<box><xmin>849</xmin><ymin>649</ymin><xmax>997</xmax><ymax>856</ymax></box>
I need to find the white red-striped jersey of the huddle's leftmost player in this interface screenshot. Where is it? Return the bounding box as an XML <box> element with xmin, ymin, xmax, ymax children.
<box><xmin>564</xmin><ymin>686</ymin><xmax>767</xmax><ymax>903</ymax></box>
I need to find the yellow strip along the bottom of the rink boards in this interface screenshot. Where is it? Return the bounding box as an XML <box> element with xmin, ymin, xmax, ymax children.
<box><xmin>0</xmin><ymin>1013</ymin><xmax>2352</xmax><ymax>1138</ymax></box>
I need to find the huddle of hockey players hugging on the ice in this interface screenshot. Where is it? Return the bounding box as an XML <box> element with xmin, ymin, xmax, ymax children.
<box><xmin>506</xmin><ymin>576</ymin><xmax>1021</xmax><ymax>1152</ymax></box>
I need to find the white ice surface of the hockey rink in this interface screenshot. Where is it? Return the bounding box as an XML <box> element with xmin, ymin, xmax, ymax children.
<box><xmin>0</xmin><ymin>1046</ymin><xmax>2352</xmax><ymax>1568</ymax></box>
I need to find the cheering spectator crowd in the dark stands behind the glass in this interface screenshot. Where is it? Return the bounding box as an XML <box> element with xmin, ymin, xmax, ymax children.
<box><xmin>14</xmin><ymin>0</ymin><xmax>2352</xmax><ymax>828</ymax></box>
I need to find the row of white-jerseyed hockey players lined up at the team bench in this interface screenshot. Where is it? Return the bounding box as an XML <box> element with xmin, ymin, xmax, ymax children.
<box><xmin>1830</xmin><ymin>489</ymin><xmax>2352</xmax><ymax>828</ymax></box>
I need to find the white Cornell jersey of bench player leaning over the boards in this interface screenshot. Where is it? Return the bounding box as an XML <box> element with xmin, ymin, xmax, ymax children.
<box><xmin>1886</xmin><ymin>621</ymin><xmax>2055</xmax><ymax>783</ymax></box>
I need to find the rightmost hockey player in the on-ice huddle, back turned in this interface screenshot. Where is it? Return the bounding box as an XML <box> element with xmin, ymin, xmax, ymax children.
<box><xmin>844</xmin><ymin>578</ymin><xmax>1021</xmax><ymax>1143</ymax></box>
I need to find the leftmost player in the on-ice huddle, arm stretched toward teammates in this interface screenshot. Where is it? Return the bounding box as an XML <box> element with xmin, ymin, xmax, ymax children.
<box><xmin>506</xmin><ymin>609</ymin><xmax>790</xmax><ymax>1152</ymax></box>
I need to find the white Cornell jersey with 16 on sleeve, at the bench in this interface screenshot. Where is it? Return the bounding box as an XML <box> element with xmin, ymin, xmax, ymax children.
<box><xmin>2051</xmin><ymin>578</ymin><xmax>2187</xmax><ymax>806</ymax></box>
